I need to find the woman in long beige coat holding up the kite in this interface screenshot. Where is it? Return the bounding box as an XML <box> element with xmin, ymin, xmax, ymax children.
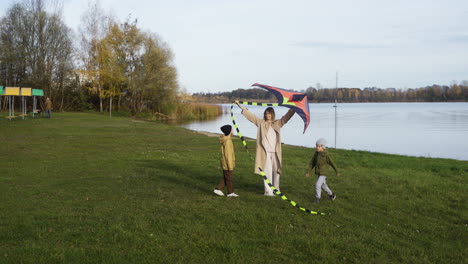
<box><xmin>236</xmin><ymin>101</ymin><xmax>294</xmax><ymax>196</ymax></box>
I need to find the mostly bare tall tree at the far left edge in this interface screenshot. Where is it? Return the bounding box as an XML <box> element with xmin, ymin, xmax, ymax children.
<box><xmin>0</xmin><ymin>0</ymin><xmax>73</xmax><ymax>108</ymax></box>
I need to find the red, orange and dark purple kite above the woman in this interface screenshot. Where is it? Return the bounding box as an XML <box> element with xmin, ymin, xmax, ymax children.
<box><xmin>252</xmin><ymin>83</ymin><xmax>310</xmax><ymax>133</ymax></box>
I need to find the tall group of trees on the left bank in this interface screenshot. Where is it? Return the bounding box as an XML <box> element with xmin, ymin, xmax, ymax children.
<box><xmin>0</xmin><ymin>0</ymin><xmax>179</xmax><ymax>114</ymax></box>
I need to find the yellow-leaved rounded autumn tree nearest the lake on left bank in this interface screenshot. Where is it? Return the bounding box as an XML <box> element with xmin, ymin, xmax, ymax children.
<box><xmin>83</xmin><ymin>17</ymin><xmax>178</xmax><ymax>115</ymax></box>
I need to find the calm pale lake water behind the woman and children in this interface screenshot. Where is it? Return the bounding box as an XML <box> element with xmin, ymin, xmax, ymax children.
<box><xmin>183</xmin><ymin>103</ymin><xmax>468</xmax><ymax>160</ymax></box>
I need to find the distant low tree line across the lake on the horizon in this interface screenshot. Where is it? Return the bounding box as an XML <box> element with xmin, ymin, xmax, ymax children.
<box><xmin>193</xmin><ymin>81</ymin><xmax>468</xmax><ymax>103</ymax></box>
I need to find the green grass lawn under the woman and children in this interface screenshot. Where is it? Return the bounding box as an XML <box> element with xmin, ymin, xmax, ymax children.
<box><xmin>0</xmin><ymin>113</ymin><xmax>468</xmax><ymax>263</ymax></box>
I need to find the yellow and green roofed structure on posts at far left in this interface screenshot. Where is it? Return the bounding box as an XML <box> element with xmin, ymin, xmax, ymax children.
<box><xmin>0</xmin><ymin>86</ymin><xmax>44</xmax><ymax>120</ymax></box>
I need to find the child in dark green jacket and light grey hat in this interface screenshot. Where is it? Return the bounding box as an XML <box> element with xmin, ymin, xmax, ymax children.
<box><xmin>306</xmin><ymin>138</ymin><xmax>340</xmax><ymax>203</ymax></box>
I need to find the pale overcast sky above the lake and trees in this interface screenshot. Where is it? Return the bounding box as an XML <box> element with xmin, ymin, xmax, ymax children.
<box><xmin>0</xmin><ymin>0</ymin><xmax>468</xmax><ymax>93</ymax></box>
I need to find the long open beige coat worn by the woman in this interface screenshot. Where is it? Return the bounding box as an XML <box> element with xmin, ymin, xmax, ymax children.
<box><xmin>241</xmin><ymin>106</ymin><xmax>294</xmax><ymax>174</ymax></box>
